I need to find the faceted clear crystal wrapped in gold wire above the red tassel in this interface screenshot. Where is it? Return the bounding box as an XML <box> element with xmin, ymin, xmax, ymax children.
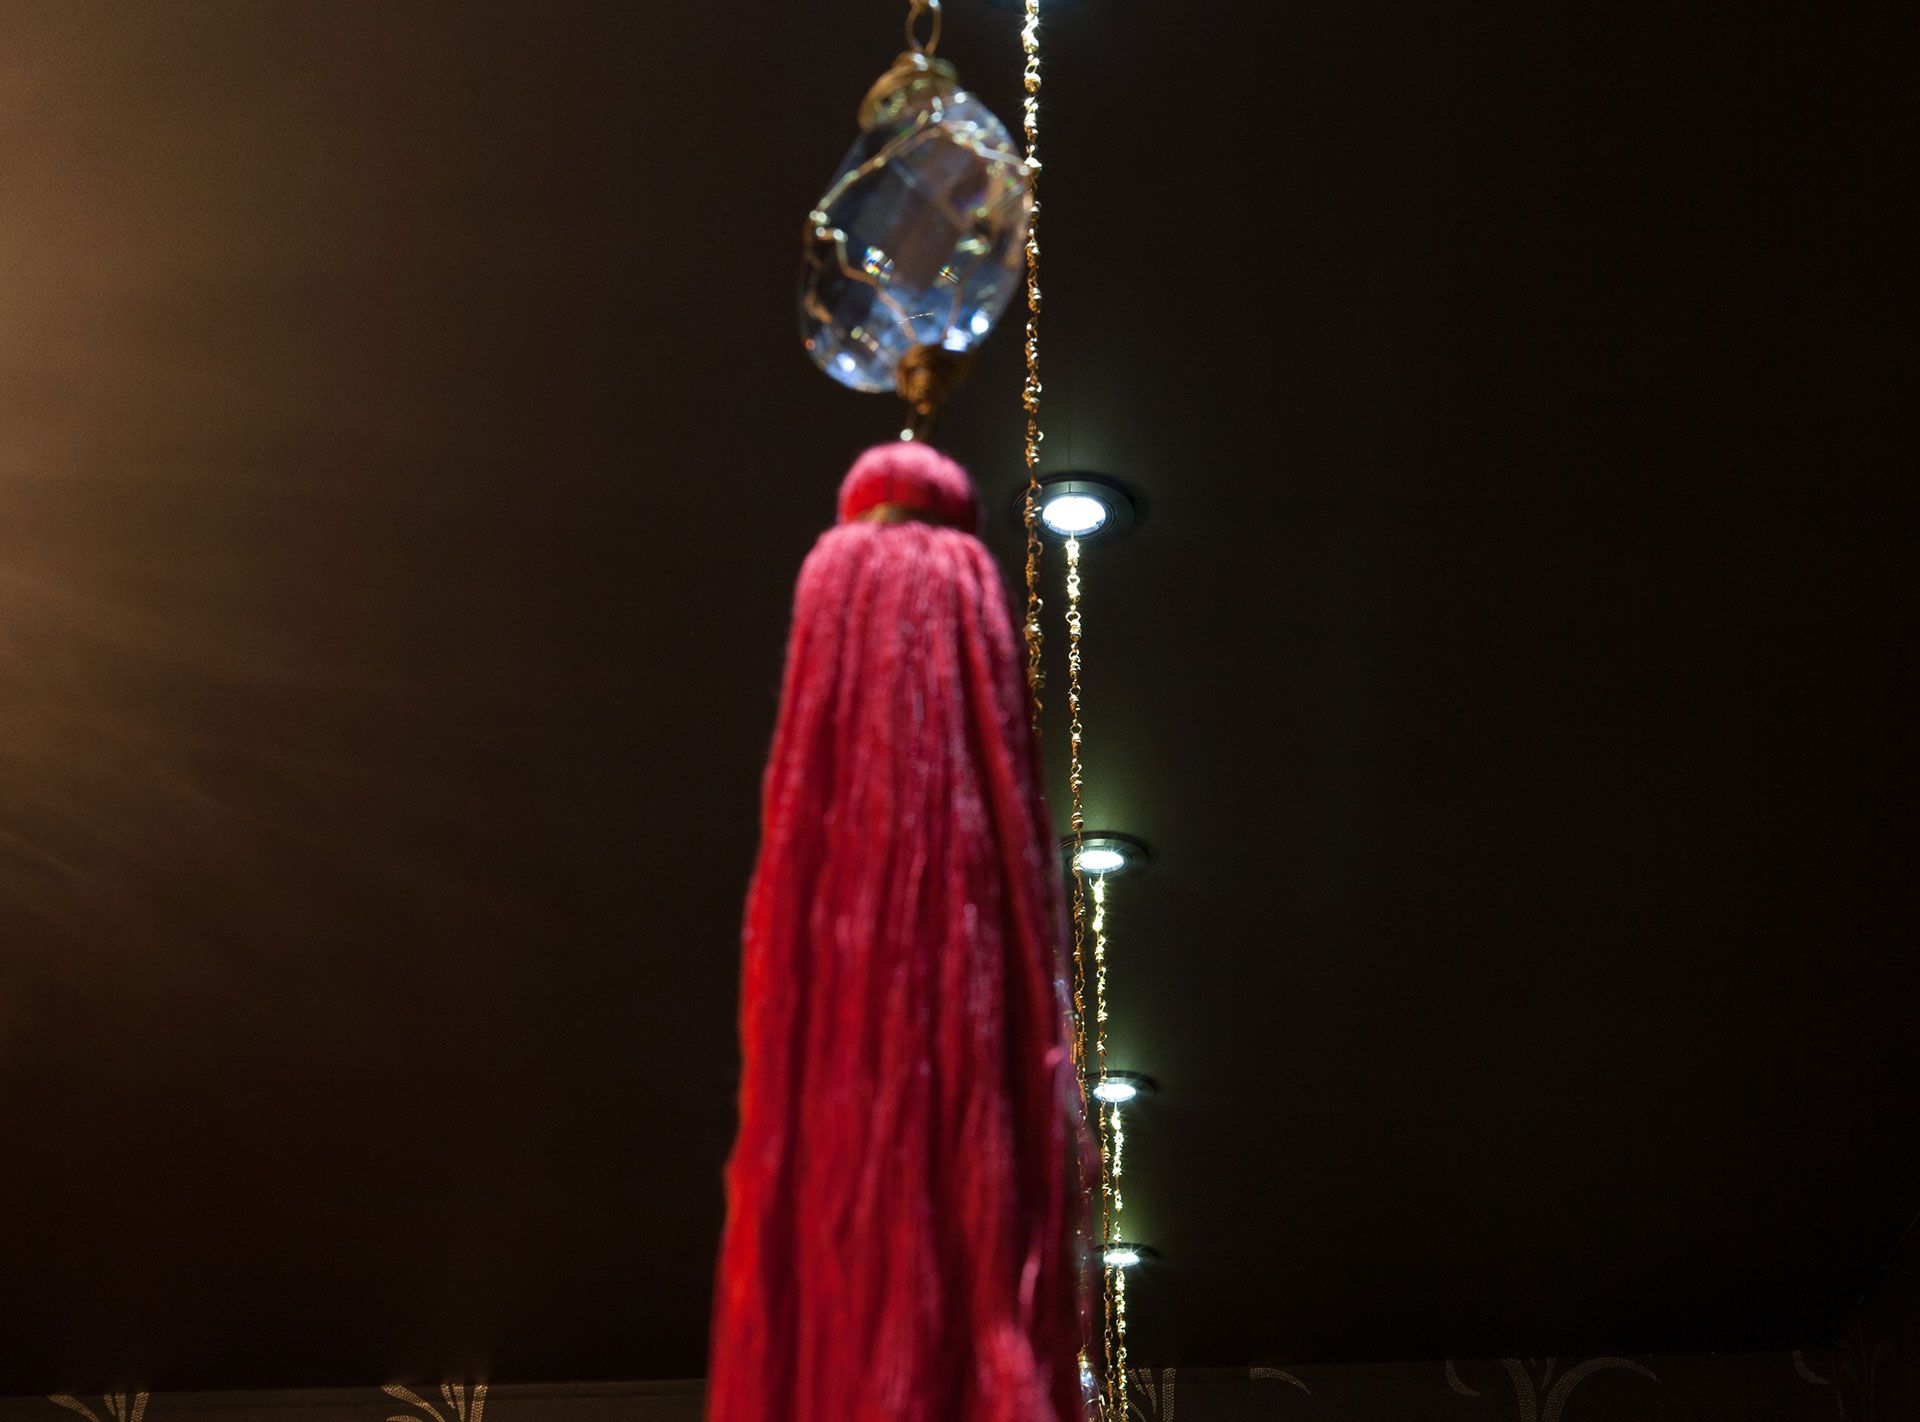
<box><xmin>801</xmin><ymin>54</ymin><xmax>1033</xmax><ymax>391</ymax></box>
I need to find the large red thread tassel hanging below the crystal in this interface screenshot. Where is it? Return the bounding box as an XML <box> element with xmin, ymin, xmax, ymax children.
<box><xmin>707</xmin><ymin>441</ymin><xmax>1087</xmax><ymax>1422</ymax></box>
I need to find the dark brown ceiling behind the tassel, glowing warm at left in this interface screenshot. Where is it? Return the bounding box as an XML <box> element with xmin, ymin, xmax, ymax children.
<box><xmin>0</xmin><ymin>0</ymin><xmax>1920</xmax><ymax>1391</ymax></box>
